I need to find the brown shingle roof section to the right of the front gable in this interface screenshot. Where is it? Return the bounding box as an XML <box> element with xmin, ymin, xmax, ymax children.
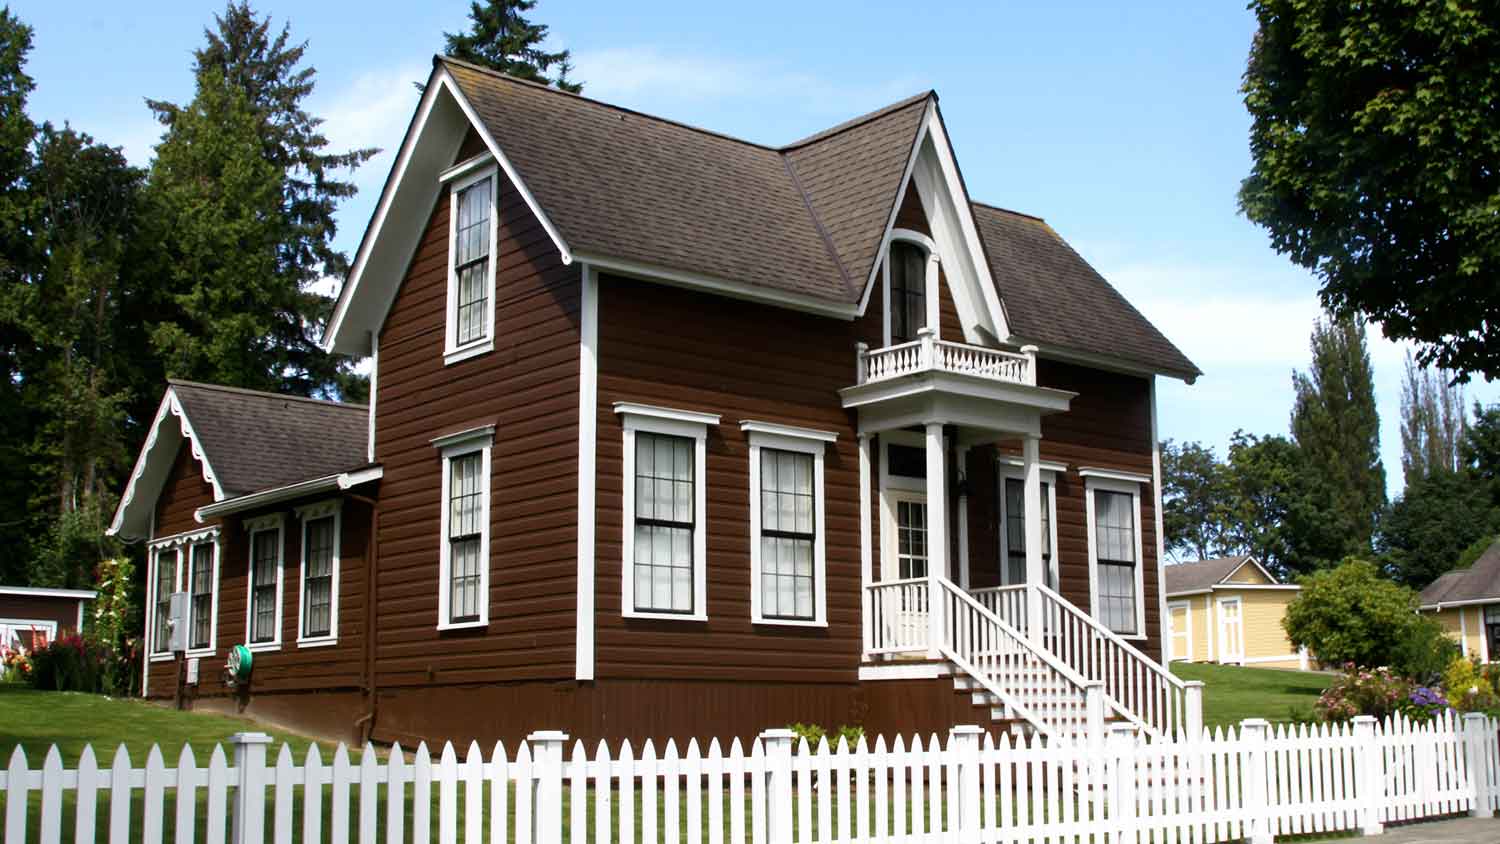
<box><xmin>974</xmin><ymin>202</ymin><xmax>1202</xmax><ymax>378</ymax></box>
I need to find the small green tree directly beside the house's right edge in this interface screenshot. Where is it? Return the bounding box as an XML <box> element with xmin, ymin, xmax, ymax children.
<box><xmin>1161</xmin><ymin>439</ymin><xmax>1229</xmax><ymax>559</ymax></box>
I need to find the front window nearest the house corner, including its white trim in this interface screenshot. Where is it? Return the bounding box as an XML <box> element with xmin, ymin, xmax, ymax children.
<box><xmin>615</xmin><ymin>402</ymin><xmax>719</xmax><ymax>621</ymax></box>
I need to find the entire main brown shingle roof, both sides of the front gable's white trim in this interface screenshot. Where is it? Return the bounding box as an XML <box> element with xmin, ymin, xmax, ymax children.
<box><xmin>437</xmin><ymin>57</ymin><xmax>1200</xmax><ymax>378</ymax></box>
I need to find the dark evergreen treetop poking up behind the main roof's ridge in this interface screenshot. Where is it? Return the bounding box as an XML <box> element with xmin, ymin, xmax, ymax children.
<box><xmin>443</xmin><ymin>0</ymin><xmax>584</xmax><ymax>93</ymax></box>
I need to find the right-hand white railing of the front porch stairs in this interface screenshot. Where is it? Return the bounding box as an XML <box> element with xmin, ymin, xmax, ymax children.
<box><xmin>1028</xmin><ymin>585</ymin><xmax>1203</xmax><ymax>738</ymax></box>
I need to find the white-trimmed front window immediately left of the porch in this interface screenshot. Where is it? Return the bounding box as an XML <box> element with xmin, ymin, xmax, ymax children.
<box><xmin>740</xmin><ymin>420</ymin><xmax>837</xmax><ymax>625</ymax></box>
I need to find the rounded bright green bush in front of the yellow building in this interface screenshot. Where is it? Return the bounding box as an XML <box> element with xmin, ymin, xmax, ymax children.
<box><xmin>1281</xmin><ymin>558</ymin><xmax>1421</xmax><ymax>669</ymax></box>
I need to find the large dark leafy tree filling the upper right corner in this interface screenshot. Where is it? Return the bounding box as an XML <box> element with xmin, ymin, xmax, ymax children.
<box><xmin>1239</xmin><ymin>0</ymin><xmax>1500</xmax><ymax>376</ymax></box>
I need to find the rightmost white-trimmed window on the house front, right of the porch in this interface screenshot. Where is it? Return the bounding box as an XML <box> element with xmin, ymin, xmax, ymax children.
<box><xmin>1080</xmin><ymin>469</ymin><xmax>1146</xmax><ymax>637</ymax></box>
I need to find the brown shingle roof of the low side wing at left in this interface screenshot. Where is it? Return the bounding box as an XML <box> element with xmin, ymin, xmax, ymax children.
<box><xmin>171</xmin><ymin>381</ymin><xmax>369</xmax><ymax>498</ymax></box>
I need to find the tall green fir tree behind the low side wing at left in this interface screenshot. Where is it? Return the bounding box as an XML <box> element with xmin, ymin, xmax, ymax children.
<box><xmin>147</xmin><ymin>3</ymin><xmax>377</xmax><ymax>399</ymax></box>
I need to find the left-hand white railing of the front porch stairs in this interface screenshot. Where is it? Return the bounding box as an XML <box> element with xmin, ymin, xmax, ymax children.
<box><xmin>938</xmin><ymin>580</ymin><xmax>1089</xmax><ymax>739</ymax></box>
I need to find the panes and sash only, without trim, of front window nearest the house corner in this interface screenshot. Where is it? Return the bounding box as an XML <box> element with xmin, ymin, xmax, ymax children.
<box><xmin>635</xmin><ymin>432</ymin><xmax>696</xmax><ymax>613</ymax></box>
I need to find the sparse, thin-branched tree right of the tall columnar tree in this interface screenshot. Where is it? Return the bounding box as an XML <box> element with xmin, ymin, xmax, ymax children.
<box><xmin>1401</xmin><ymin>354</ymin><xmax>1469</xmax><ymax>486</ymax></box>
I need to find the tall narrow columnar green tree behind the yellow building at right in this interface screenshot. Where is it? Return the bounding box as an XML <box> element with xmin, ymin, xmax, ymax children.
<box><xmin>1292</xmin><ymin>318</ymin><xmax>1386</xmax><ymax>561</ymax></box>
